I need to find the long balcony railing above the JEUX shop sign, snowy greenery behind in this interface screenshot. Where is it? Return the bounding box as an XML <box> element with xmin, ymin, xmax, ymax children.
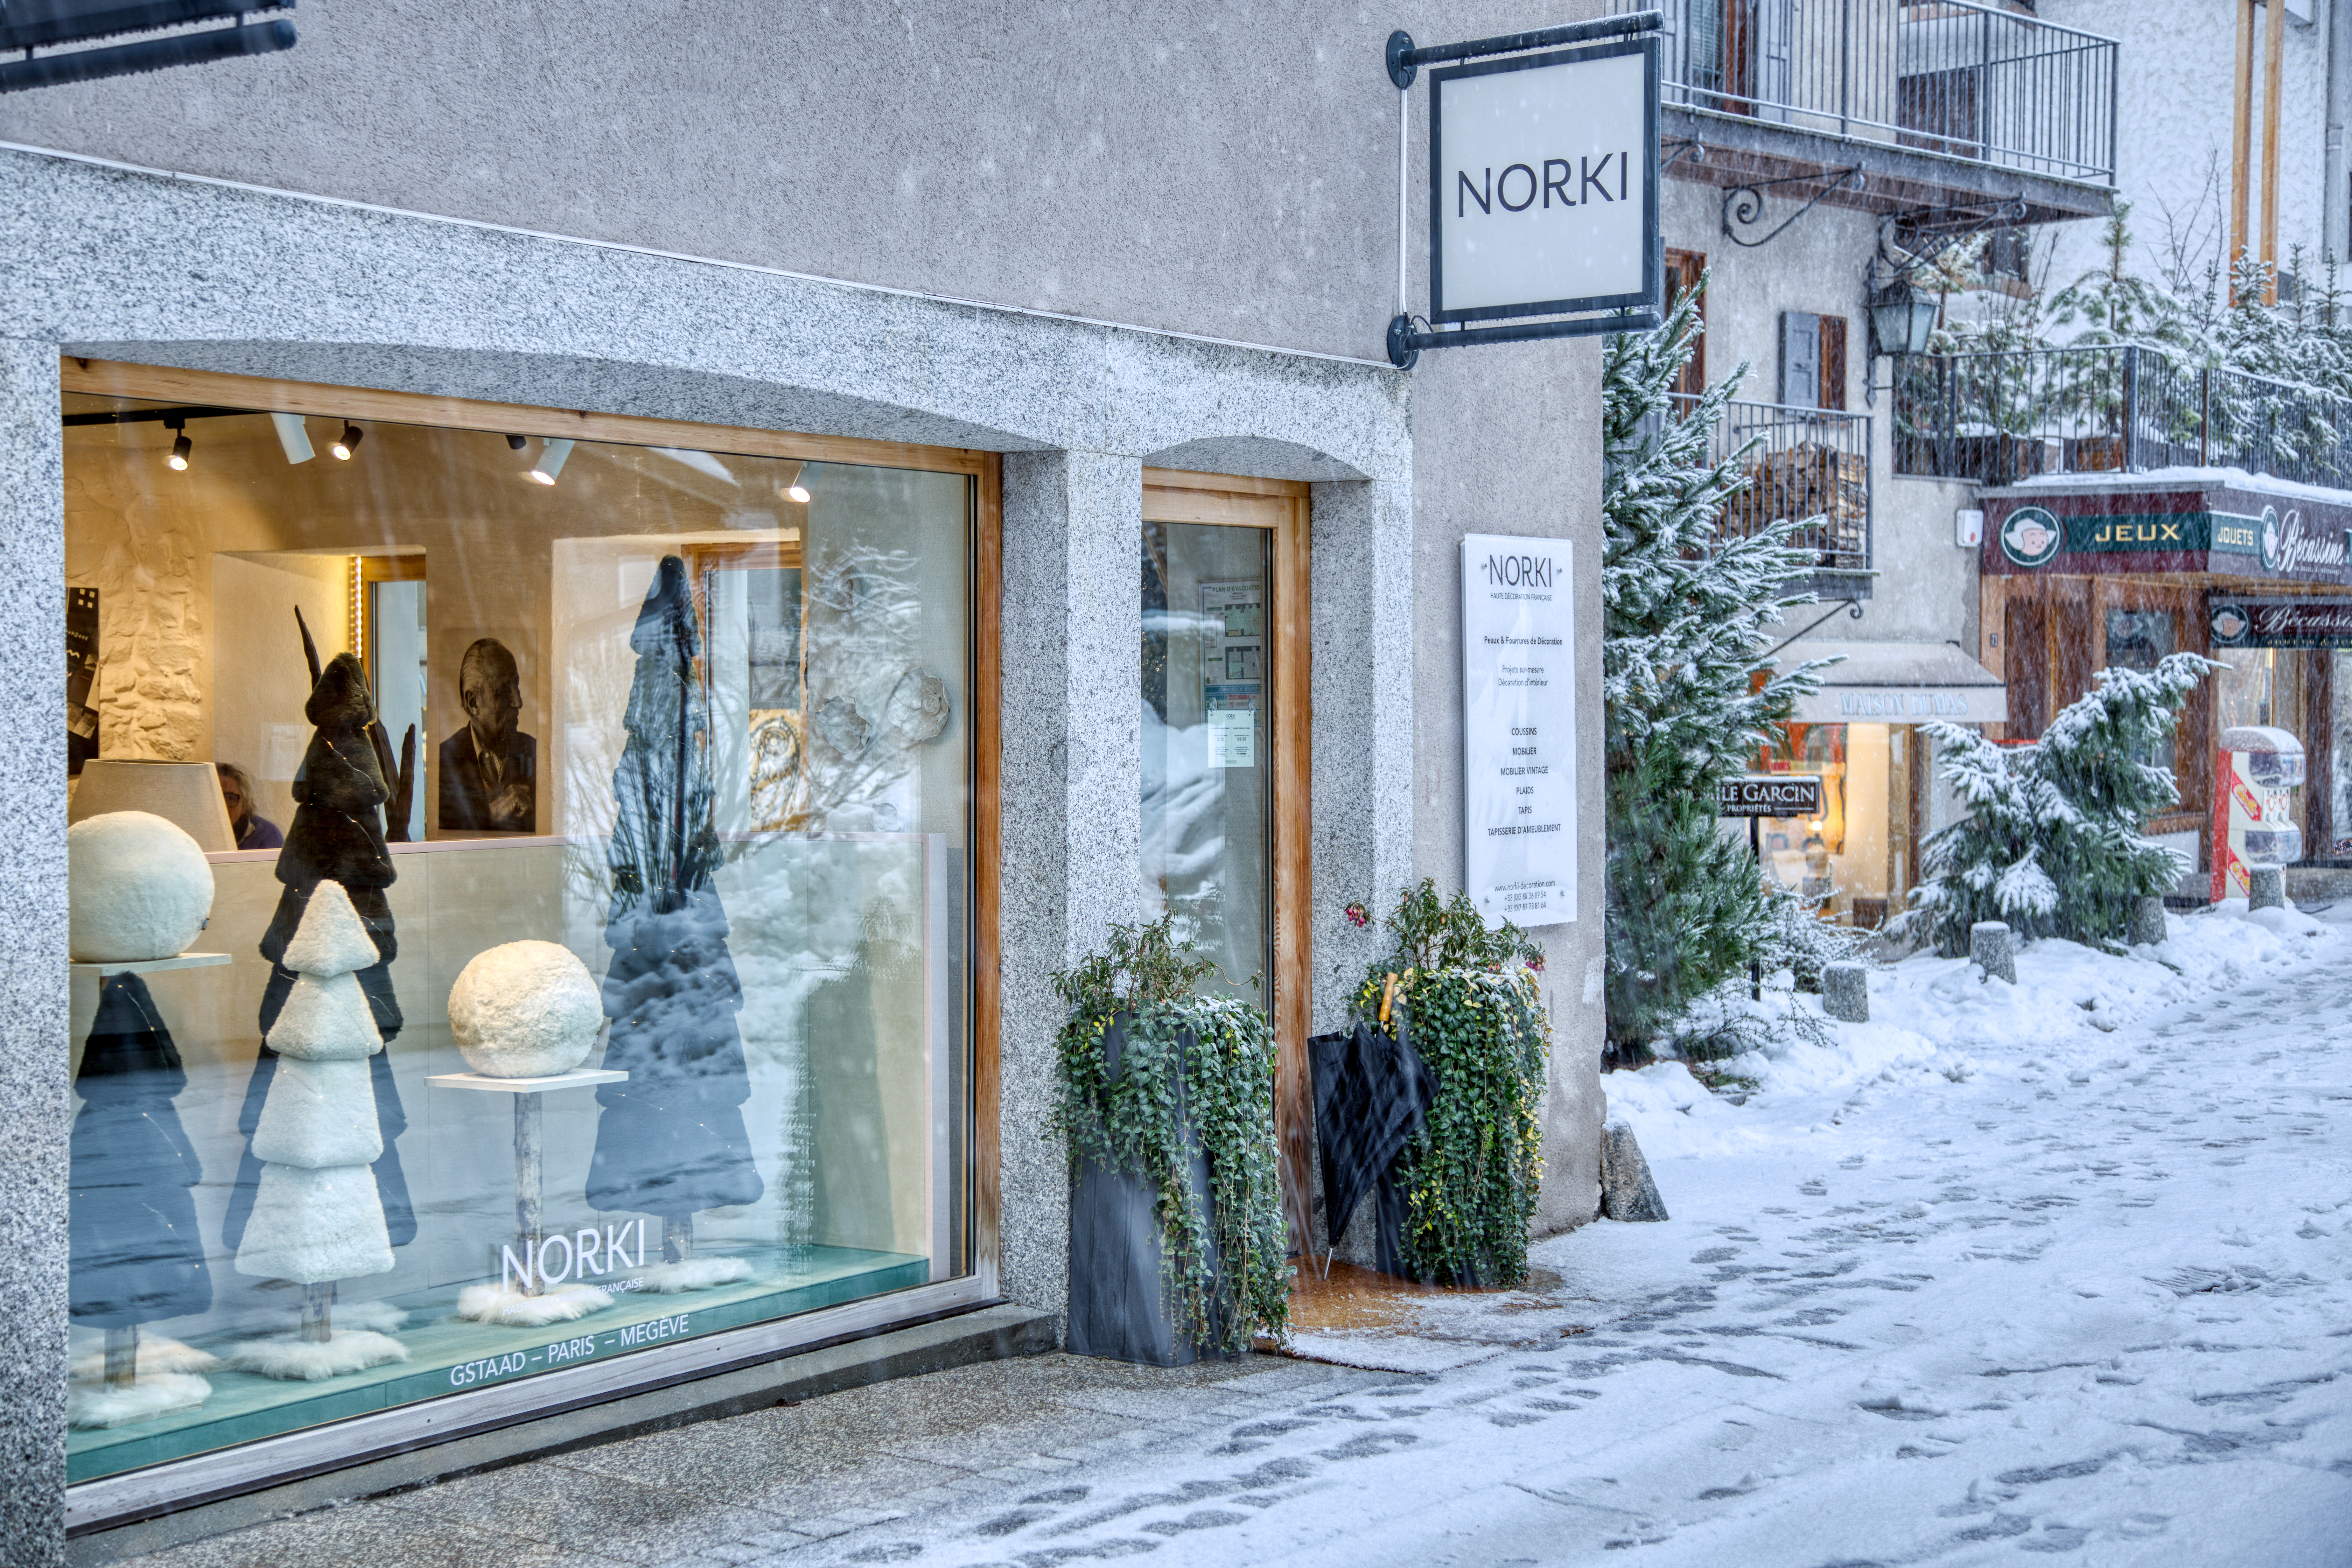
<box><xmin>1893</xmin><ymin>348</ymin><xmax>2352</xmax><ymax>489</ymax></box>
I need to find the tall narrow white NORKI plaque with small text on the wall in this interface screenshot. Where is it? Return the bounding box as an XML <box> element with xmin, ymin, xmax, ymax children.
<box><xmin>1463</xmin><ymin>534</ymin><xmax>1576</xmax><ymax>926</ymax></box>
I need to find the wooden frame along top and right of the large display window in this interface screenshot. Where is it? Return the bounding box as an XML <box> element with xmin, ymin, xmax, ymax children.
<box><xmin>59</xmin><ymin>355</ymin><xmax>1011</xmax><ymax>1297</ymax></box>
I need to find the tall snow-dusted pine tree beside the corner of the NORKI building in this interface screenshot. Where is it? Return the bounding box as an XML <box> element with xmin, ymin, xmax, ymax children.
<box><xmin>1602</xmin><ymin>280</ymin><xmax>1816</xmax><ymax>1063</ymax></box>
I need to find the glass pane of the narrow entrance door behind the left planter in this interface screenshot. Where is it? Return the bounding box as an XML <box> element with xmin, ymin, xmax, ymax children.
<box><xmin>1141</xmin><ymin>519</ymin><xmax>1275</xmax><ymax>1006</ymax></box>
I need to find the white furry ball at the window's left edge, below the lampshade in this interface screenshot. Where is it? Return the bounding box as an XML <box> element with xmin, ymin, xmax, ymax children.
<box><xmin>66</xmin><ymin>811</ymin><xmax>212</xmax><ymax>964</ymax></box>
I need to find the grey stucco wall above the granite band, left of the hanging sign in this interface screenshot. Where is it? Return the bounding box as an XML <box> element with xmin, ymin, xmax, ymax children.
<box><xmin>0</xmin><ymin>0</ymin><xmax>1600</xmax><ymax>357</ymax></box>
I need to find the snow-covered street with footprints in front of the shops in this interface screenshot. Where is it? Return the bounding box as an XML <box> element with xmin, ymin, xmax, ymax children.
<box><xmin>124</xmin><ymin>908</ymin><xmax>2352</xmax><ymax>1568</ymax></box>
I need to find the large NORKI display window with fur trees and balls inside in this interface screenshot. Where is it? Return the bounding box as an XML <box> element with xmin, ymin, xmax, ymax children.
<box><xmin>63</xmin><ymin>367</ymin><xmax>988</xmax><ymax>1481</ymax></box>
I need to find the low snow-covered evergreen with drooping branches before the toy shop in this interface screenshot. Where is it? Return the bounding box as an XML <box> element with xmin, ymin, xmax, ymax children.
<box><xmin>1891</xmin><ymin>653</ymin><xmax>2220</xmax><ymax>957</ymax></box>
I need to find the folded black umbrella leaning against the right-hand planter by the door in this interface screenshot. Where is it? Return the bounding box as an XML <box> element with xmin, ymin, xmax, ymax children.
<box><xmin>1308</xmin><ymin>1023</ymin><xmax>1437</xmax><ymax>1274</ymax></box>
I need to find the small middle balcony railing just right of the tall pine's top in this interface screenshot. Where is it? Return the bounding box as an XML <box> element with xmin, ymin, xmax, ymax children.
<box><xmin>1675</xmin><ymin>395</ymin><xmax>1870</xmax><ymax>590</ymax></box>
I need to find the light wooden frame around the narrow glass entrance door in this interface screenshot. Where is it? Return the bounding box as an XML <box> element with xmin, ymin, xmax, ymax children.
<box><xmin>1143</xmin><ymin>468</ymin><xmax>1315</xmax><ymax>1246</ymax></box>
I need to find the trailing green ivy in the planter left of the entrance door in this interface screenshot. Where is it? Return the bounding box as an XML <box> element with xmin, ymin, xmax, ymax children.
<box><xmin>1051</xmin><ymin>917</ymin><xmax>1289</xmax><ymax>1352</ymax></box>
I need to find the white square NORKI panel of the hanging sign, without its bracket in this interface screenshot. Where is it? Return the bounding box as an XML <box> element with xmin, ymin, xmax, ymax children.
<box><xmin>1430</xmin><ymin>40</ymin><xmax>1660</xmax><ymax>322</ymax></box>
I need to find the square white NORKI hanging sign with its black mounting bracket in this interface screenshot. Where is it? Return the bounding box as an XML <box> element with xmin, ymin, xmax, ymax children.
<box><xmin>1388</xmin><ymin>12</ymin><xmax>1665</xmax><ymax>369</ymax></box>
